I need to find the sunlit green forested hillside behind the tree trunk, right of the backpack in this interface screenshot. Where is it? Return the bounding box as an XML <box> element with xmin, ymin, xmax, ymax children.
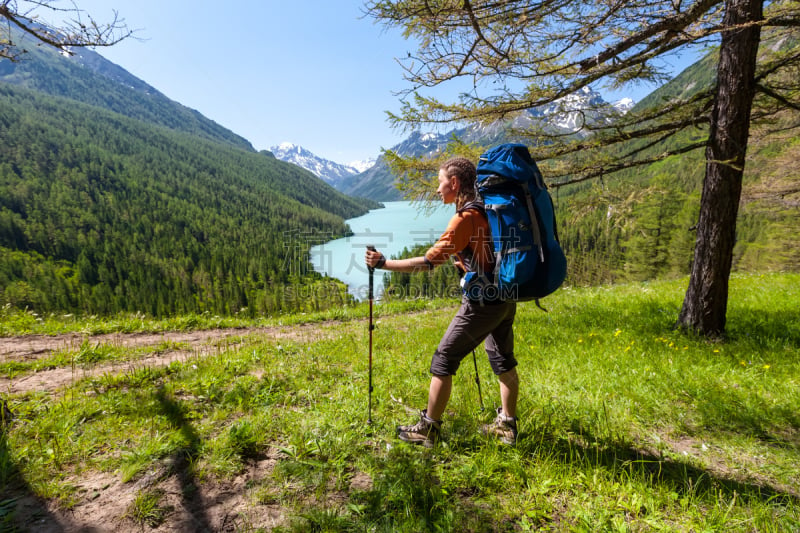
<box><xmin>553</xmin><ymin>39</ymin><xmax>800</xmax><ymax>284</ymax></box>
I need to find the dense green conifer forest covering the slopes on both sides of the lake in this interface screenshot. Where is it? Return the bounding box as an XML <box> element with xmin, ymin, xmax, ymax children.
<box><xmin>0</xmin><ymin>26</ymin><xmax>800</xmax><ymax>316</ymax></box>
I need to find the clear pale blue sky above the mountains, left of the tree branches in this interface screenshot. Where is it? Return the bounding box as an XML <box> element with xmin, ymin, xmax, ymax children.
<box><xmin>48</xmin><ymin>0</ymin><xmax>700</xmax><ymax>163</ymax></box>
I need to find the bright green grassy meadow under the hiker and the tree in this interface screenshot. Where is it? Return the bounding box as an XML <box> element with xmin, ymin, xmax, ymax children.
<box><xmin>0</xmin><ymin>274</ymin><xmax>800</xmax><ymax>532</ymax></box>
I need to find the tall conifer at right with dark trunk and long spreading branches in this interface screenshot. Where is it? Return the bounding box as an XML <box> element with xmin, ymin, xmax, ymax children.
<box><xmin>366</xmin><ymin>0</ymin><xmax>800</xmax><ymax>336</ymax></box>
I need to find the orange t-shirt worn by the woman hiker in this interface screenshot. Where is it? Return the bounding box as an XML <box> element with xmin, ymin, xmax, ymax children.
<box><xmin>425</xmin><ymin>209</ymin><xmax>494</xmax><ymax>273</ymax></box>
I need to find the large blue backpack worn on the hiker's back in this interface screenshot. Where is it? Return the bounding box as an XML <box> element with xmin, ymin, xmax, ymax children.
<box><xmin>462</xmin><ymin>144</ymin><xmax>567</xmax><ymax>307</ymax></box>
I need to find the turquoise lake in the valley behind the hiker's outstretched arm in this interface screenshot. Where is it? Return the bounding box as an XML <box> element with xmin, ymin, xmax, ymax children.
<box><xmin>311</xmin><ymin>202</ymin><xmax>455</xmax><ymax>300</ymax></box>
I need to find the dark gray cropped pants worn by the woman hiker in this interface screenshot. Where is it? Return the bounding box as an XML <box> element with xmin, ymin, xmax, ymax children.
<box><xmin>431</xmin><ymin>298</ymin><xmax>517</xmax><ymax>376</ymax></box>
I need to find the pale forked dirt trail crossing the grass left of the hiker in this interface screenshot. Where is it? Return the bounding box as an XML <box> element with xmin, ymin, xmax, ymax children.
<box><xmin>0</xmin><ymin>322</ymin><xmax>336</xmax><ymax>394</ymax></box>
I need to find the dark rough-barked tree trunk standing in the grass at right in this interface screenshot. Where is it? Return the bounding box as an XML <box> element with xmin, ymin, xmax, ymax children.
<box><xmin>678</xmin><ymin>0</ymin><xmax>763</xmax><ymax>337</ymax></box>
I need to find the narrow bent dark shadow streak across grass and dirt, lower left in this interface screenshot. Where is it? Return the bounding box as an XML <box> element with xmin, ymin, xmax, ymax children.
<box><xmin>156</xmin><ymin>388</ymin><xmax>214</xmax><ymax>531</ymax></box>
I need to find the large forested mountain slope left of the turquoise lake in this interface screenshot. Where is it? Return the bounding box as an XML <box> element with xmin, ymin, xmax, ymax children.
<box><xmin>0</xmin><ymin>39</ymin><xmax>375</xmax><ymax>316</ymax></box>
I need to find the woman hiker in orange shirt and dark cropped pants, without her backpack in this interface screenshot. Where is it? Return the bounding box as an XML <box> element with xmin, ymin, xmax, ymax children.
<box><xmin>365</xmin><ymin>157</ymin><xmax>519</xmax><ymax>447</ymax></box>
